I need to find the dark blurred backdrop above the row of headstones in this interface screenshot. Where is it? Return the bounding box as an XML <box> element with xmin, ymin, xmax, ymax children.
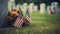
<box><xmin>15</xmin><ymin>0</ymin><xmax>60</xmax><ymax>10</ymax></box>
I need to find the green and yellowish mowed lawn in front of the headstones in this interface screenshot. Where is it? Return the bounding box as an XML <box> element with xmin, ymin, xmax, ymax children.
<box><xmin>2</xmin><ymin>12</ymin><xmax>60</xmax><ymax>34</ymax></box>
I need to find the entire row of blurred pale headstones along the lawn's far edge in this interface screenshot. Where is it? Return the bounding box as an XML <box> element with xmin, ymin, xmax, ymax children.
<box><xmin>8</xmin><ymin>0</ymin><xmax>58</xmax><ymax>14</ymax></box>
